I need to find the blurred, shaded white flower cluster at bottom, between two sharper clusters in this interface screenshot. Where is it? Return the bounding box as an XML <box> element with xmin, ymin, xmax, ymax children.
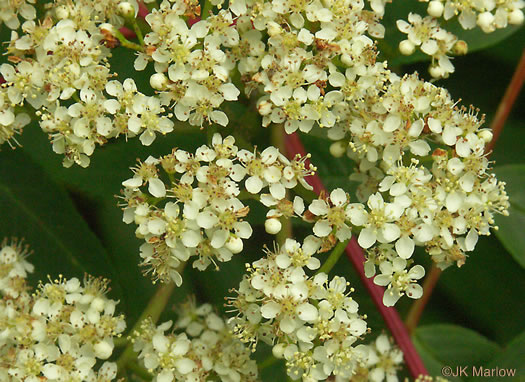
<box><xmin>132</xmin><ymin>298</ymin><xmax>257</xmax><ymax>382</ymax></box>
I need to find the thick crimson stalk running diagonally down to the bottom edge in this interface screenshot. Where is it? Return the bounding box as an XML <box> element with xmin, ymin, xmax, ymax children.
<box><xmin>286</xmin><ymin>133</ymin><xmax>428</xmax><ymax>378</ymax></box>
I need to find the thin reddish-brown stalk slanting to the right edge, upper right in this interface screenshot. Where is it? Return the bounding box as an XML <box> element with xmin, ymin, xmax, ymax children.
<box><xmin>485</xmin><ymin>49</ymin><xmax>525</xmax><ymax>153</ymax></box>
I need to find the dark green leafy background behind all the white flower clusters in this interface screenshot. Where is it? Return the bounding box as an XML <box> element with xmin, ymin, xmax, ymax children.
<box><xmin>0</xmin><ymin>1</ymin><xmax>525</xmax><ymax>381</ymax></box>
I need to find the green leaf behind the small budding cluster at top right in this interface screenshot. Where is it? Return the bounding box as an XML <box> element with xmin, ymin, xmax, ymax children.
<box><xmin>378</xmin><ymin>0</ymin><xmax>521</xmax><ymax>66</ymax></box>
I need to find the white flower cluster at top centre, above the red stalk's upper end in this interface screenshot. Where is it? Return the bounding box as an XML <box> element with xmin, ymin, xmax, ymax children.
<box><xmin>241</xmin><ymin>0</ymin><xmax>385</xmax><ymax>133</ymax></box>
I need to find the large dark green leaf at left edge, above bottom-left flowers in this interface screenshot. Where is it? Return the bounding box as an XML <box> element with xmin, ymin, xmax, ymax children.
<box><xmin>0</xmin><ymin>150</ymin><xmax>120</xmax><ymax>295</ymax></box>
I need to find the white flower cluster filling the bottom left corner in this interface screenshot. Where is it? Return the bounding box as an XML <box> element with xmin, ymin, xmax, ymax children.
<box><xmin>0</xmin><ymin>241</ymin><xmax>126</xmax><ymax>382</ymax></box>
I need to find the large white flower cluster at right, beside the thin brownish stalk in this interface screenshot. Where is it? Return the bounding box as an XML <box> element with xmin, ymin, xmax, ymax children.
<box><xmin>329</xmin><ymin>75</ymin><xmax>509</xmax><ymax>278</ymax></box>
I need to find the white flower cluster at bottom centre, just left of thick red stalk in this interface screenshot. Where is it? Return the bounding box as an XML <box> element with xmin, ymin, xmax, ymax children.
<box><xmin>229</xmin><ymin>236</ymin><xmax>368</xmax><ymax>381</ymax></box>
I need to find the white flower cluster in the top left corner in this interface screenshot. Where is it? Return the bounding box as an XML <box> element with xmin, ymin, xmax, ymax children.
<box><xmin>0</xmin><ymin>0</ymin><xmax>129</xmax><ymax>166</ymax></box>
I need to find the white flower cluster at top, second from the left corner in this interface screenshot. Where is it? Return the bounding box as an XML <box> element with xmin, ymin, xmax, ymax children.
<box><xmin>135</xmin><ymin>1</ymin><xmax>240</xmax><ymax>126</ymax></box>
